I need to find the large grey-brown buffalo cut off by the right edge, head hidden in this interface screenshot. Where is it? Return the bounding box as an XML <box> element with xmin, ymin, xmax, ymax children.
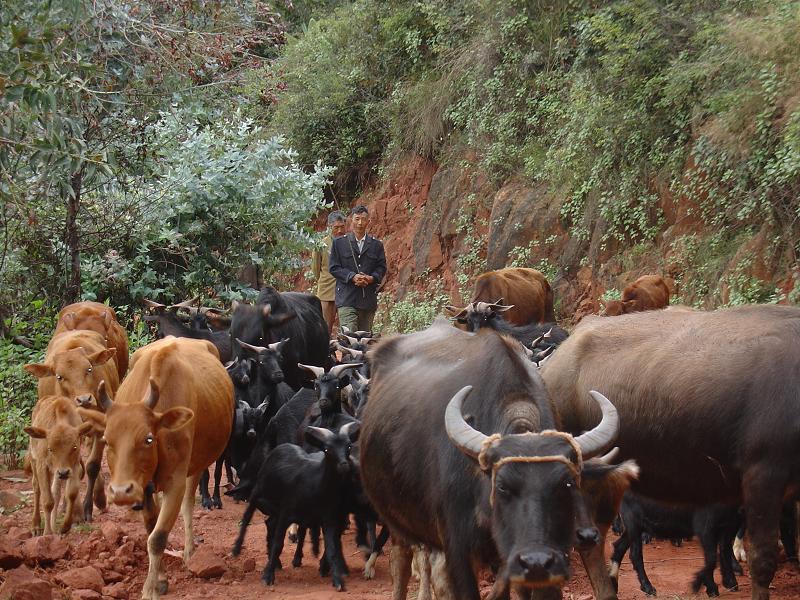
<box><xmin>542</xmin><ymin>306</ymin><xmax>800</xmax><ymax>600</ymax></box>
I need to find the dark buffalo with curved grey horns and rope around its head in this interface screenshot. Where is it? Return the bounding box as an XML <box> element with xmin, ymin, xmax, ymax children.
<box><xmin>360</xmin><ymin>319</ymin><xmax>636</xmax><ymax>600</ymax></box>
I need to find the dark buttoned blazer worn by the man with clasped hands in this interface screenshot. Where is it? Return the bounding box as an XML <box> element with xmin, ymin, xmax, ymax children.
<box><xmin>328</xmin><ymin>232</ymin><xmax>386</xmax><ymax>310</ymax></box>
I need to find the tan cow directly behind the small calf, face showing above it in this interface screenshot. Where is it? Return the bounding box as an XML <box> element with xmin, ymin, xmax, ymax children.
<box><xmin>25</xmin><ymin>329</ymin><xmax>119</xmax><ymax>521</ymax></box>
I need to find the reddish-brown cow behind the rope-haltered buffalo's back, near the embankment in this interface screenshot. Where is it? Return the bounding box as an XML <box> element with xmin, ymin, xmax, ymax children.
<box><xmin>447</xmin><ymin>267</ymin><xmax>556</xmax><ymax>325</ymax></box>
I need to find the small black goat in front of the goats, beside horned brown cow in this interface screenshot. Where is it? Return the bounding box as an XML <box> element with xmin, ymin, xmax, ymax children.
<box><xmin>233</xmin><ymin>422</ymin><xmax>359</xmax><ymax>590</ymax></box>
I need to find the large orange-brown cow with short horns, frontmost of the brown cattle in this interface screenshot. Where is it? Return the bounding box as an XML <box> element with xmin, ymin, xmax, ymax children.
<box><xmin>82</xmin><ymin>337</ymin><xmax>233</xmax><ymax>599</ymax></box>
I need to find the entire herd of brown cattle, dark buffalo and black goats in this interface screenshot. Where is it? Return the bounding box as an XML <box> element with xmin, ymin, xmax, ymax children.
<box><xmin>17</xmin><ymin>268</ymin><xmax>800</xmax><ymax>600</ymax></box>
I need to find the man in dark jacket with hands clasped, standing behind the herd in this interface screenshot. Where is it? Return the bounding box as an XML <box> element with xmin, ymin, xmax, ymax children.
<box><xmin>328</xmin><ymin>206</ymin><xmax>386</xmax><ymax>331</ymax></box>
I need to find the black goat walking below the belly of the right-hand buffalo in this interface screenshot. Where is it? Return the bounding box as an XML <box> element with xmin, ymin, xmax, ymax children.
<box><xmin>610</xmin><ymin>492</ymin><xmax>741</xmax><ymax>597</ymax></box>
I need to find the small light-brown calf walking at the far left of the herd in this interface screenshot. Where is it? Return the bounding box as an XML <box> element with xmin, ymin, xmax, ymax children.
<box><xmin>25</xmin><ymin>396</ymin><xmax>92</xmax><ymax>535</ymax></box>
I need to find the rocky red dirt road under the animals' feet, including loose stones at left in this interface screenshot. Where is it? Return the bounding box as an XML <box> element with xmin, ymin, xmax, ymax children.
<box><xmin>0</xmin><ymin>471</ymin><xmax>800</xmax><ymax>600</ymax></box>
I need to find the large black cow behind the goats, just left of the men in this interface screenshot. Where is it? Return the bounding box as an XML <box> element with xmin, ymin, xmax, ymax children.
<box><xmin>230</xmin><ymin>287</ymin><xmax>330</xmax><ymax>389</ymax></box>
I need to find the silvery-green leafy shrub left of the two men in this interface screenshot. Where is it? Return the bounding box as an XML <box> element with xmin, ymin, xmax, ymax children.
<box><xmin>82</xmin><ymin>110</ymin><xmax>330</xmax><ymax>304</ymax></box>
